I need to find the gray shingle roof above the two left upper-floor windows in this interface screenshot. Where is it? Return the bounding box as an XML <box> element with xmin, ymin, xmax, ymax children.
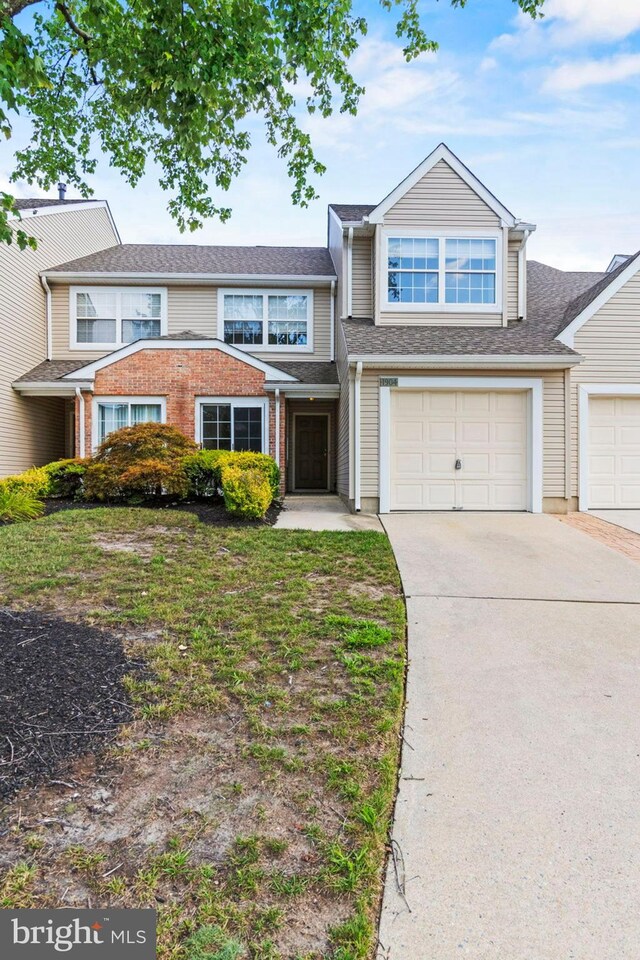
<box><xmin>47</xmin><ymin>243</ymin><xmax>336</xmax><ymax>278</ymax></box>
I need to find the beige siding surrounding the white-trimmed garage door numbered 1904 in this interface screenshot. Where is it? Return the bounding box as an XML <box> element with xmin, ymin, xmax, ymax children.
<box><xmin>360</xmin><ymin>368</ymin><xmax>564</xmax><ymax>497</ymax></box>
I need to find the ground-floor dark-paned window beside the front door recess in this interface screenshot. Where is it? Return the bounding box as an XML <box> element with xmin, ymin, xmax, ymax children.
<box><xmin>197</xmin><ymin>397</ymin><xmax>267</xmax><ymax>453</ymax></box>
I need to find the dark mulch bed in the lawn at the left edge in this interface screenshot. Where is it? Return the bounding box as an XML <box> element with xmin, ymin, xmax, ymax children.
<box><xmin>0</xmin><ymin>608</ymin><xmax>140</xmax><ymax>799</ymax></box>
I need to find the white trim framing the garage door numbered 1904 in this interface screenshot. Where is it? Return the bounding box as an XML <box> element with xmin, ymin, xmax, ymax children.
<box><xmin>379</xmin><ymin>377</ymin><xmax>544</xmax><ymax>513</ymax></box>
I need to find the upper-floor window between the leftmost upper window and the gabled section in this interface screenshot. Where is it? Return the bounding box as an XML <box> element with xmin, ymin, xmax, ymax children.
<box><xmin>220</xmin><ymin>290</ymin><xmax>313</xmax><ymax>350</ymax></box>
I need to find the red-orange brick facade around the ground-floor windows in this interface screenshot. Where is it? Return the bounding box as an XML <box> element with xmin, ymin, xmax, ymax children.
<box><xmin>76</xmin><ymin>348</ymin><xmax>287</xmax><ymax>490</ymax></box>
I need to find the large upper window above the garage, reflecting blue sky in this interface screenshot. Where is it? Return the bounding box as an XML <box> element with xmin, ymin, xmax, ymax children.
<box><xmin>387</xmin><ymin>237</ymin><xmax>499</xmax><ymax>310</ymax></box>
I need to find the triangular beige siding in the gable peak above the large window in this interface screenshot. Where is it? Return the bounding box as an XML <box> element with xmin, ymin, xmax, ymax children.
<box><xmin>384</xmin><ymin>160</ymin><xmax>500</xmax><ymax>228</ymax></box>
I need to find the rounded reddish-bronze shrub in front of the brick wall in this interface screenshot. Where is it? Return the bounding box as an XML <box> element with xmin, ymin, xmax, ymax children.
<box><xmin>93</xmin><ymin>423</ymin><xmax>198</xmax><ymax>471</ymax></box>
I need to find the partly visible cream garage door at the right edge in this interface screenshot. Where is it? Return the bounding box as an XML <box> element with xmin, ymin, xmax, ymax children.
<box><xmin>589</xmin><ymin>397</ymin><xmax>640</xmax><ymax>510</ymax></box>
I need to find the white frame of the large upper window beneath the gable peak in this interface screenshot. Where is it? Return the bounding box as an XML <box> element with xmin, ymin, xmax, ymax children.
<box><xmin>379</xmin><ymin>227</ymin><xmax>504</xmax><ymax>314</ymax></box>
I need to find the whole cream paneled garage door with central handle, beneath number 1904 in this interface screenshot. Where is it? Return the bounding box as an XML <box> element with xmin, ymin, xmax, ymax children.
<box><xmin>390</xmin><ymin>390</ymin><xmax>529</xmax><ymax>510</ymax></box>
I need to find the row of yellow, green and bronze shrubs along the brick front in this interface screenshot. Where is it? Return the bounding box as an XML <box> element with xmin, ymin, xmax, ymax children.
<box><xmin>0</xmin><ymin>424</ymin><xmax>280</xmax><ymax>521</ymax></box>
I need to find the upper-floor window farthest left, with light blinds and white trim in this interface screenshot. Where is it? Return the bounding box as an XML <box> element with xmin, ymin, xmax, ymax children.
<box><xmin>70</xmin><ymin>287</ymin><xmax>166</xmax><ymax>349</ymax></box>
